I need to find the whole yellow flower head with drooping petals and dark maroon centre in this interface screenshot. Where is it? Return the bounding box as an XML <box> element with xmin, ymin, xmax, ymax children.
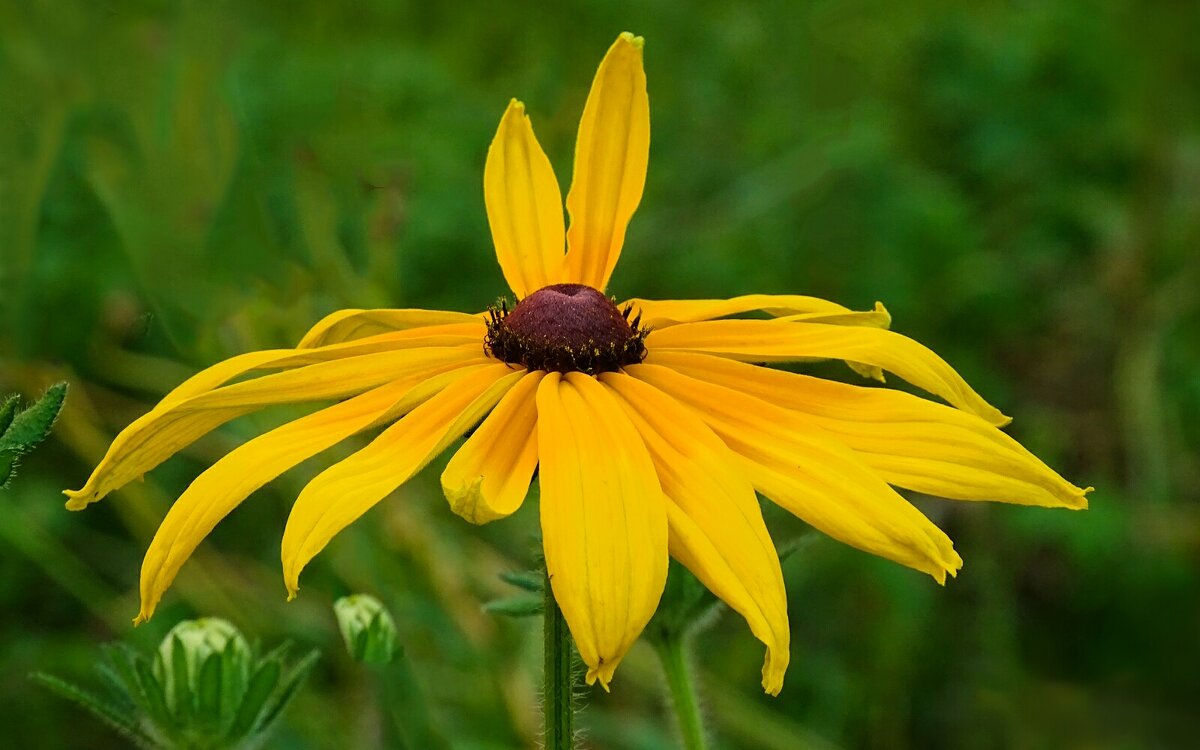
<box><xmin>67</xmin><ymin>34</ymin><xmax>1087</xmax><ymax>694</ymax></box>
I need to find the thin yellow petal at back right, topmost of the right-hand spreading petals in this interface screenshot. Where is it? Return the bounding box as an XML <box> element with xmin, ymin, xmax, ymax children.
<box><xmin>620</xmin><ymin>294</ymin><xmax>892</xmax><ymax>328</ymax></box>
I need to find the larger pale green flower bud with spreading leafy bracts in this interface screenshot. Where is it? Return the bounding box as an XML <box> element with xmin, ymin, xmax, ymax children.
<box><xmin>31</xmin><ymin>618</ymin><xmax>318</xmax><ymax>750</ymax></box>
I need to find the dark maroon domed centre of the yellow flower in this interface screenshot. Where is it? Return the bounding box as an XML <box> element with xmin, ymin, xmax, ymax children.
<box><xmin>485</xmin><ymin>284</ymin><xmax>649</xmax><ymax>374</ymax></box>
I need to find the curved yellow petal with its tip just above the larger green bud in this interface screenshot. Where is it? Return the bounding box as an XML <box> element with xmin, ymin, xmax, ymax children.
<box><xmin>133</xmin><ymin>368</ymin><xmax>466</xmax><ymax>624</ymax></box>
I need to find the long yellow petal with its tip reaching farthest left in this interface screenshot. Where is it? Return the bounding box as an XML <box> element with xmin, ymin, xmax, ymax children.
<box><xmin>66</xmin><ymin>344</ymin><xmax>485</xmax><ymax>510</ymax></box>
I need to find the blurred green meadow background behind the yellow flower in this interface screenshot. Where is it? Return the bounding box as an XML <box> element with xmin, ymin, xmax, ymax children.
<box><xmin>0</xmin><ymin>0</ymin><xmax>1200</xmax><ymax>750</ymax></box>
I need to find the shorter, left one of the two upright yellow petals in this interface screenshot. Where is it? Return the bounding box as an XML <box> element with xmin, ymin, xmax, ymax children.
<box><xmin>484</xmin><ymin>100</ymin><xmax>564</xmax><ymax>299</ymax></box>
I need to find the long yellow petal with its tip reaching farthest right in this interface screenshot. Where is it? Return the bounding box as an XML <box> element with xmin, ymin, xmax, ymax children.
<box><xmin>646</xmin><ymin>352</ymin><xmax>1091</xmax><ymax>509</ymax></box>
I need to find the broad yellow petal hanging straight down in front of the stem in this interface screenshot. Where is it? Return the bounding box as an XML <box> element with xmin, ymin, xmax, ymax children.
<box><xmin>538</xmin><ymin>372</ymin><xmax>667</xmax><ymax>689</ymax></box>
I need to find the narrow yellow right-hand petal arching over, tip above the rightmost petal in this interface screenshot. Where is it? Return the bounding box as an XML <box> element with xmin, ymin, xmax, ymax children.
<box><xmin>646</xmin><ymin>320</ymin><xmax>1012</xmax><ymax>425</ymax></box>
